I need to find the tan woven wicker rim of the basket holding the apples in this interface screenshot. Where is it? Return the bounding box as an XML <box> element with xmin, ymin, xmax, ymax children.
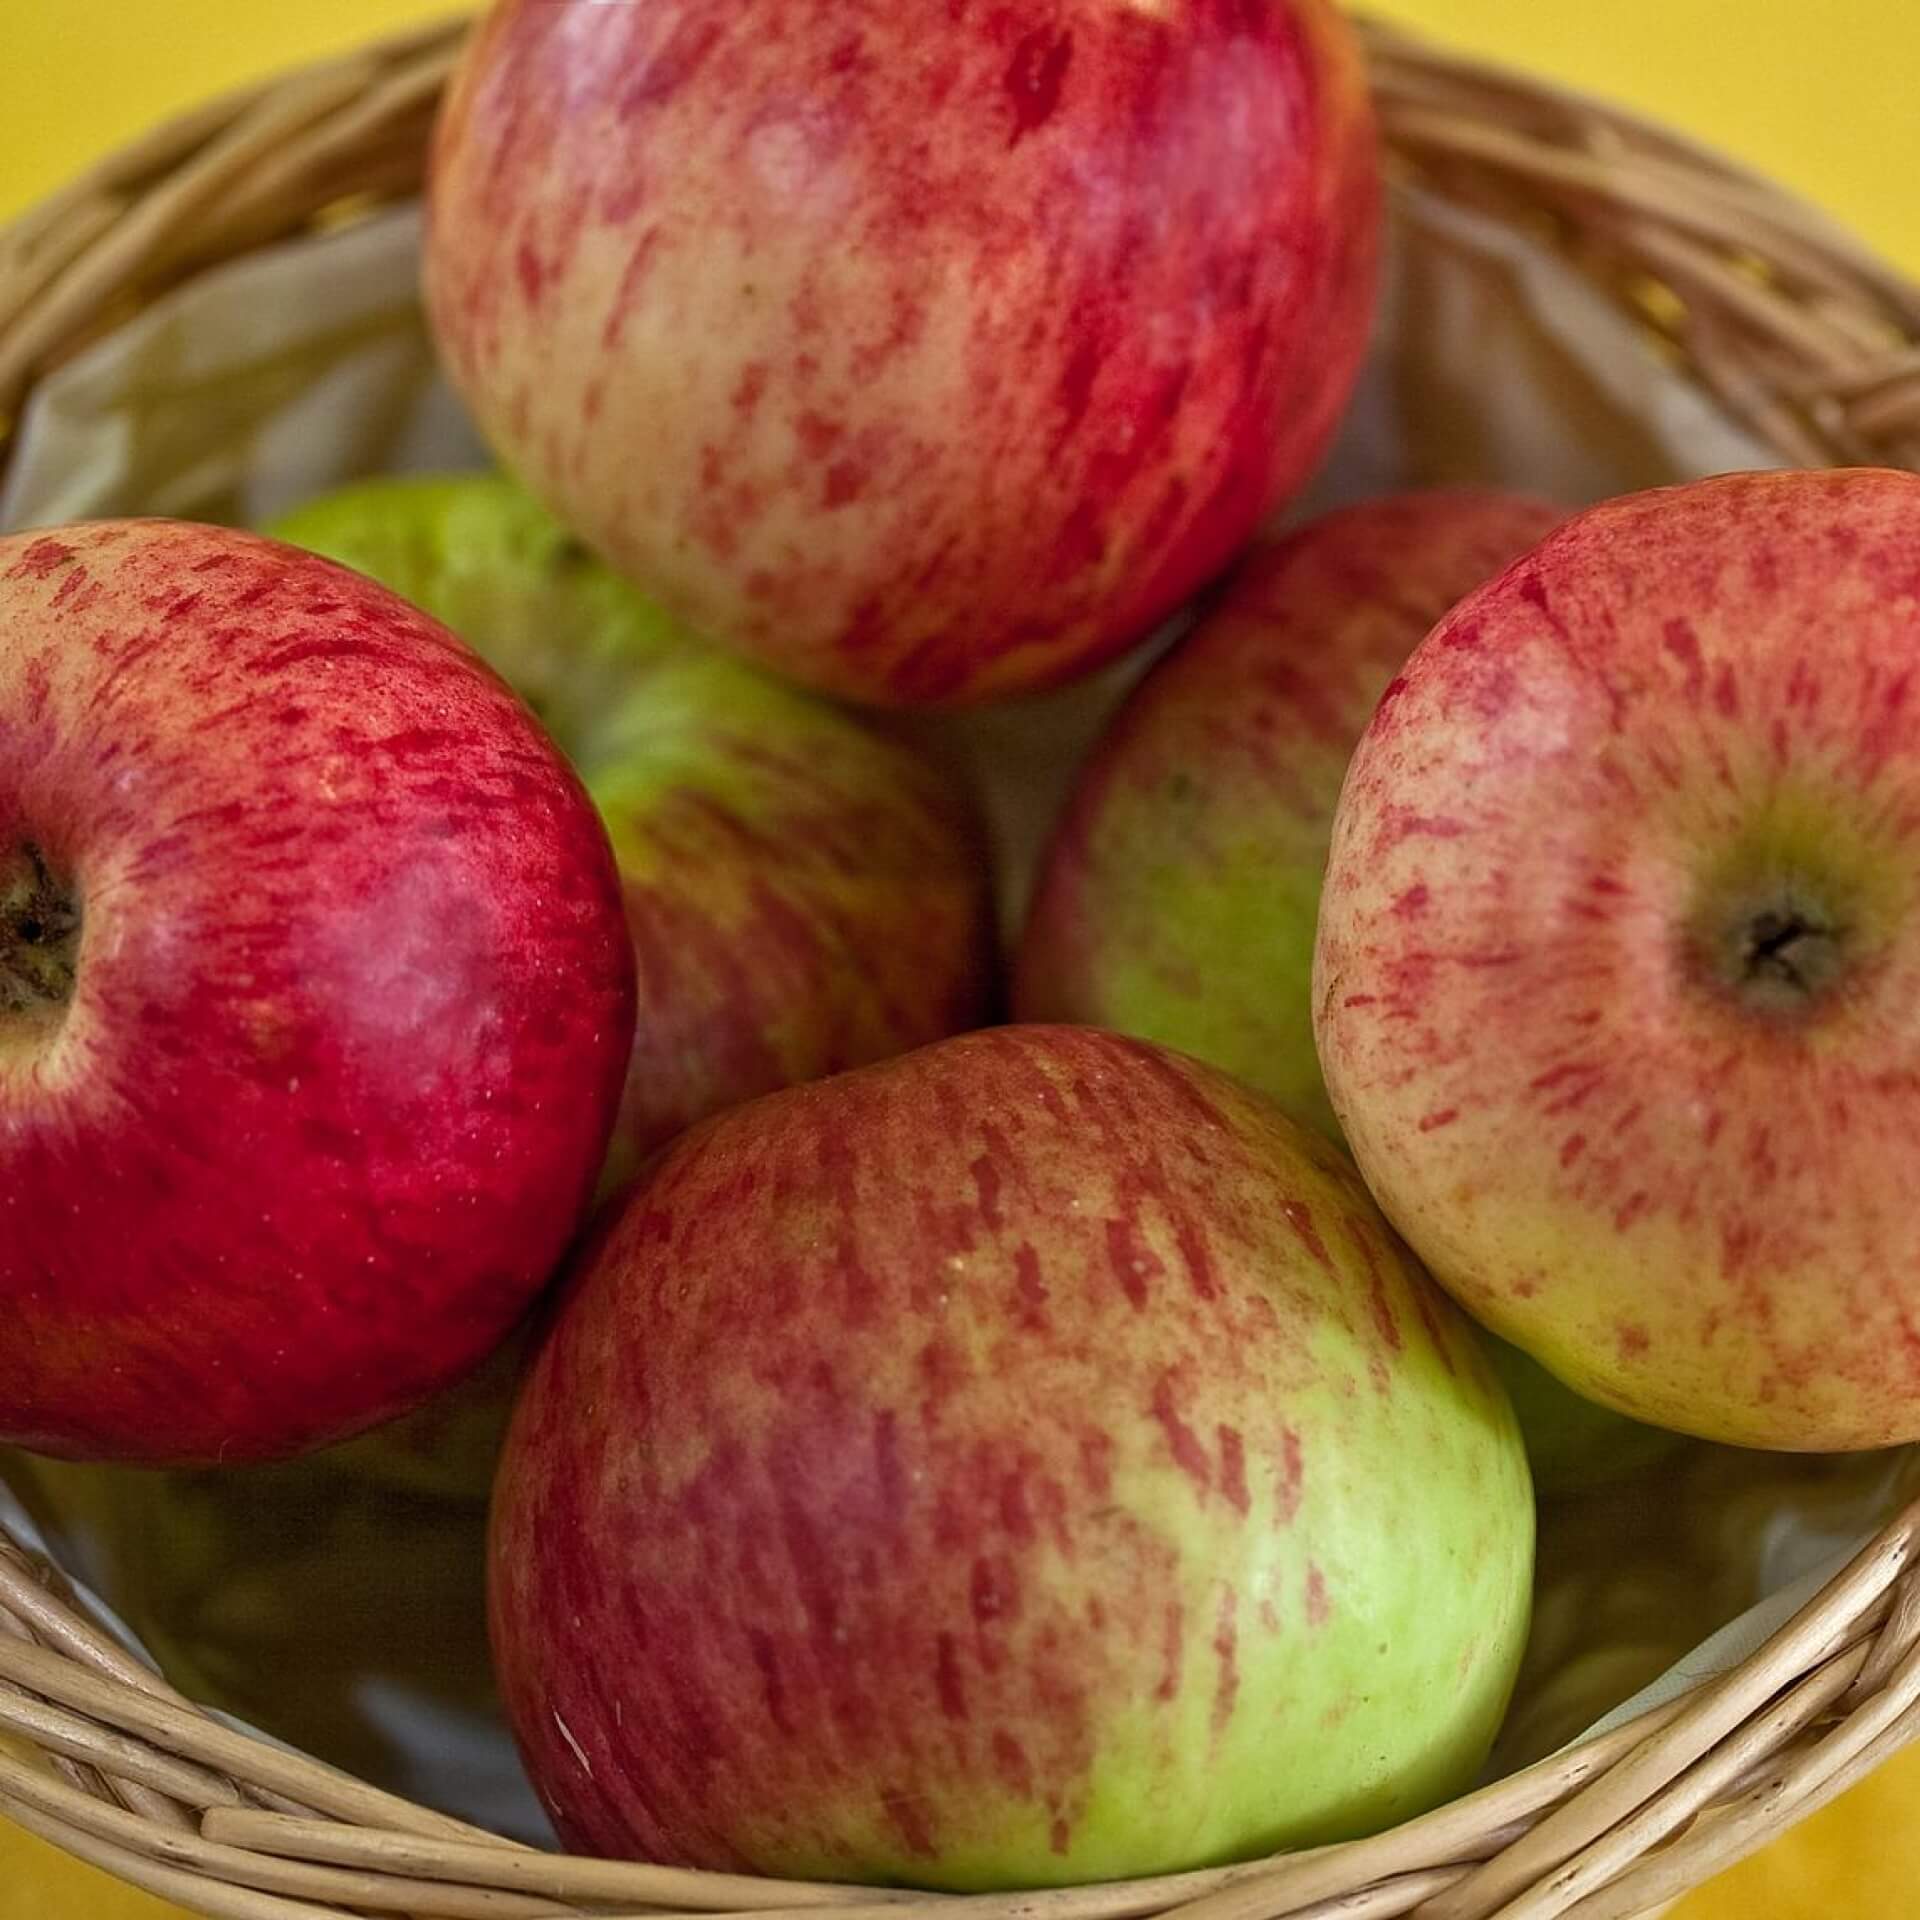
<box><xmin>0</xmin><ymin>25</ymin><xmax>1920</xmax><ymax>1920</ymax></box>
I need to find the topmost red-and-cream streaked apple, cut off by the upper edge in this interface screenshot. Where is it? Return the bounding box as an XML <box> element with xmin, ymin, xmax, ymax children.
<box><xmin>424</xmin><ymin>0</ymin><xmax>1380</xmax><ymax>705</ymax></box>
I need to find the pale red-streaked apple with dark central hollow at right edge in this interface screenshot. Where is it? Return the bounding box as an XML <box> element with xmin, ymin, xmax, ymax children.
<box><xmin>1315</xmin><ymin>470</ymin><xmax>1920</xmax><ymax>1452</ymax></box>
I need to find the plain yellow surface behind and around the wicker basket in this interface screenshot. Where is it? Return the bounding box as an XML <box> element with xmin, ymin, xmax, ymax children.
<box><xmin>0</xmin><ymin>0</ymin><xmax>1920</xmax><ymax>1920</ymax></box>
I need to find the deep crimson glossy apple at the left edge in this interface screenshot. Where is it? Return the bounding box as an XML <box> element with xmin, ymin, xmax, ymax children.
<box><xmin>0</xmin><ymin>520</ymin><xmax>634</xmax><ymax>1463</ymax></box>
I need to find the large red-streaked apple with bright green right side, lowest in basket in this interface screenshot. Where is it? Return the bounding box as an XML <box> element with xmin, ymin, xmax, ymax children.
<box><xmin>490</xmin><ymin>1027</ymin><xmax>1532</xmax><ymax>1889</ymax></box>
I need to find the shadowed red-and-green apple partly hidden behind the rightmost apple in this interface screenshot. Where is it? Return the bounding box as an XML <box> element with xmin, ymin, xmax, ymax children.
<box><xmin>1014</xmin><ymin>490</ymin><xmax>1561</xmax><ymax>1139</ymax></box>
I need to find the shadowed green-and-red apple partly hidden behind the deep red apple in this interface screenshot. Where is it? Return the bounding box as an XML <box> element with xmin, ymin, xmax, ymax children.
<box><xmin>273</xmin><ymin>474</ymin><xmax>995</xmax><ymax>1185</ymax></box>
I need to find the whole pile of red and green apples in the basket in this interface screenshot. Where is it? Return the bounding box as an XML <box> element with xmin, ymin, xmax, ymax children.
<box><xmin>0</xmin><ymin>0</ymin><xmax>1920</xmax><ymax>1887</ymax></box>
